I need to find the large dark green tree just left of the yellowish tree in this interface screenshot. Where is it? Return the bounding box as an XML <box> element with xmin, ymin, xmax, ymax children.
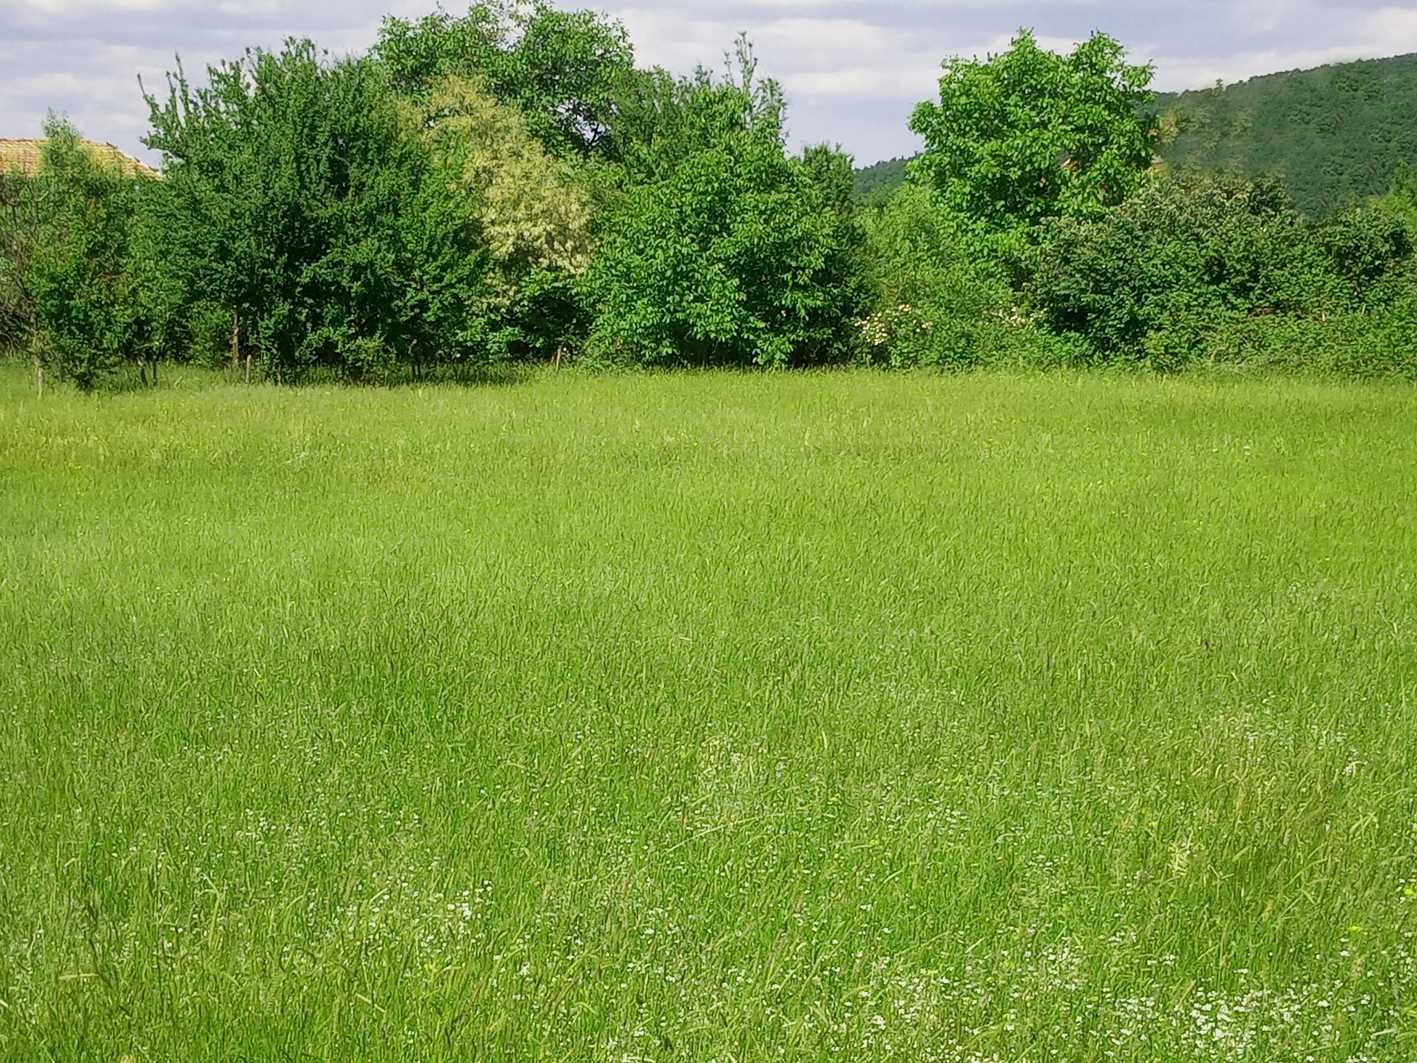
<box><xmin>149</xmin><ymin>41</ymin><xmax>504</xmax><ymax>380</ymax></box>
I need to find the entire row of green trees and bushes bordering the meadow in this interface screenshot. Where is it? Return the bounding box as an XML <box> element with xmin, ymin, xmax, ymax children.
<box><xmin>0</xmin><ymin>1</ymin><xmax>1417</xmax><ymax>388</ymax></box>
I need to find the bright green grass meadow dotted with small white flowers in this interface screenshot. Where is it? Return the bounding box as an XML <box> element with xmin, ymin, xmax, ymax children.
<box><xmin>0</xmin><ymin>369</ymin><xmax>1417</xmax><ymax>1062</ymax></box>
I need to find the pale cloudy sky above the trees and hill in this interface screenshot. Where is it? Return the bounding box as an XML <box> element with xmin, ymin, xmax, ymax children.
<box><xmin>8</xmin><ymin>0</ymin><xmax>1417</xmax><ymax>164</ymax></box>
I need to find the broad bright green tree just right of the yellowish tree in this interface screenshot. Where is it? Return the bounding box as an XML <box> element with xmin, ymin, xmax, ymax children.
<box><xmin>585</xmin><ymin>41</ymin><xmax>866</xmax><ymax>366</ymax></box>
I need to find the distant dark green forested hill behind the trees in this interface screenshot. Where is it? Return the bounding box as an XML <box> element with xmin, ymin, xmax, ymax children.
<box><xmin>857</xmin><ymin>54</ymin><xmax>1417</xmax><ymax>217</ymax></box>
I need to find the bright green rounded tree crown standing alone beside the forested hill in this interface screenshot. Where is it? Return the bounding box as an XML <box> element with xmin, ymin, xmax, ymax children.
<box><xmin>910</xmin><ymin>31</ymin><xmax>1158</xmax><ymax>251</ymax></box>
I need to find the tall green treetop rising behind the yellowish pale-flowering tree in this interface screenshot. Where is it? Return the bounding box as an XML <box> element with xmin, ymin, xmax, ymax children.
<box><xmin>373</xmin><ymin>0</ymin><xmax>633</xmax><ymax>156</ymax></box>
